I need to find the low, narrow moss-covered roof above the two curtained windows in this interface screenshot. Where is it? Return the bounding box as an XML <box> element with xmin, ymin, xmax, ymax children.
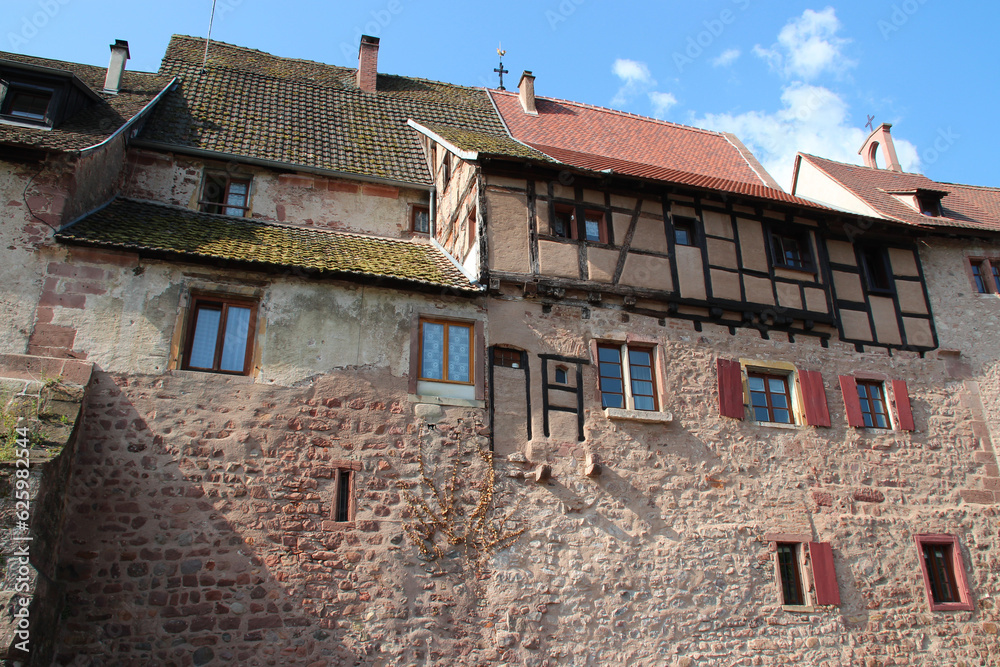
<box><xmin>56</xmin><ymin>198</ymin><xmax>477</xmax><ymax>291</ymax></box>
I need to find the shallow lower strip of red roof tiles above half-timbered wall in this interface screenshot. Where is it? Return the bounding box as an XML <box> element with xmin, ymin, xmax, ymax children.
<box><xmin>528</xmin><ymin>144</ymin><xmax>833</xmax><ymax>211</ymax></box>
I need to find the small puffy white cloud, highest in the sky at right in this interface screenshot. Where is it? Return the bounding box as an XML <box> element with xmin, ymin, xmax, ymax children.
<box><xmin>753</xmin><ymin>7</ymin><xmax>857</xmax><ymax>81</ymax></box>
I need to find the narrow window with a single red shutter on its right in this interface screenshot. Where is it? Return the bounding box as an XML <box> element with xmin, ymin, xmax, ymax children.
<box><xmin>765</xmin><ymin>534</ymin><xmax>840</xmax><ymax>611</ymax></box>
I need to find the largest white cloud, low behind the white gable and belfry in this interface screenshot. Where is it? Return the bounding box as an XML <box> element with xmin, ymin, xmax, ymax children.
<box><xmin>694</xmin><ymin>82</ymin><xmax>920</xmax><ymax>190</ymax></box>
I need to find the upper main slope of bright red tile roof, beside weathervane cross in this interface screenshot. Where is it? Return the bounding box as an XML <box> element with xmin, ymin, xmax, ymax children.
<box><xmin>489</xmin><ymin>90</ymin><xmax>775</xmax><ymax>186</ymax></box>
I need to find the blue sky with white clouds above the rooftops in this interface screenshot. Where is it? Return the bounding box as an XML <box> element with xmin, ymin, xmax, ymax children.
<box><xmin>0</xmin><ymin>0</ymin><xmax>1000</xmax><ymax>187</ymax></box>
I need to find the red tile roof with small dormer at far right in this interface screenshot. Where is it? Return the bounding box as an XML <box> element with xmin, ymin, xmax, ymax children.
<box><xmin>799</xmin><ymin>153</ymin><xmax>1000</xmax><ymax>231</ymax></box>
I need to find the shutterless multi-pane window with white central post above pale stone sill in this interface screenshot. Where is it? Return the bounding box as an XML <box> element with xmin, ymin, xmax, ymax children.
<box><xmin>597</xmin><ymin>344</ymin><xmax>657</xmax><ymax>411</ymax></box>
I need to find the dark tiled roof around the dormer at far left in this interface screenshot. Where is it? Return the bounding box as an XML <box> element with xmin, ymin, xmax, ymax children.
<box><xmin>0</xmin><ymin>52</ymin><xmax>170</xmax><ymax>152</ymax></box>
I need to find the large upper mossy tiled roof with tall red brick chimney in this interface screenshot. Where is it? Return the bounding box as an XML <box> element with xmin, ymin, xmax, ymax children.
<box><xmin>141</xmin><ymin>35</ymin><xmax>516</xmax><ymax>185</ymax></box>
